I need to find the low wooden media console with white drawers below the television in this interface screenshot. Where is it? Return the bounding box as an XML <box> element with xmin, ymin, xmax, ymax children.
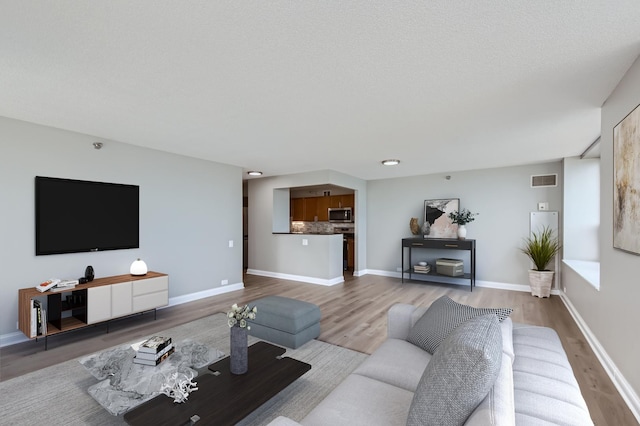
<box><xmin>18</xmin><ymin>272</ymin><xmax>169</xmax><ymax>350</ymax></box>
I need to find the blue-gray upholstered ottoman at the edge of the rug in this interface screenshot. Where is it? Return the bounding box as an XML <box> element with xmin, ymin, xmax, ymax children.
<box><xmin>249</xmin><ymin>296</ymin><xmax>320</xmax><ymax>349</ymax></box>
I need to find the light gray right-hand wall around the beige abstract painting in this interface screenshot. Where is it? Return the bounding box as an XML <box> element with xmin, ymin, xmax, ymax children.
<box><xmin>564</xmin><ymin>58</ymin><xmax>640</xmax><ymax>418</ymax></box>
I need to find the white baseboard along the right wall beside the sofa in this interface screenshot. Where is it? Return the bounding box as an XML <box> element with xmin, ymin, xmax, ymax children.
<box><xmin>560</xmin><ymin>292</ymin><xmax>640</xmax><ymax>423</ymax></box>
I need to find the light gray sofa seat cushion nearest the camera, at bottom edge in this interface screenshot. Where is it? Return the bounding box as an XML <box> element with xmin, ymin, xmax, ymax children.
<box><xmin>300</xmin><ymin>374</ymin><xmax>413</xmax><ymax>426</ymax></box>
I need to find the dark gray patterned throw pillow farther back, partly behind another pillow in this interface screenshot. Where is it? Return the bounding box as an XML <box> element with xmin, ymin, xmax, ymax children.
<box><xmin>407</xmin><ymin>296</ymin><xmax>513</xmax><ymax>354</ymax></box>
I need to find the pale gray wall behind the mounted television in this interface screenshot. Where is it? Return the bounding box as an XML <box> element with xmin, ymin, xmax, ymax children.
<box><xmin>0</xmin><ymin>117</ymin><xmax>242</xmax><ymax>335</ymax></box>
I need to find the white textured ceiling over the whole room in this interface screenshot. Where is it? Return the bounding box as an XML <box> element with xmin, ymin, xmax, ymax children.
<box><xmin>0</xmin><ymin>0</ymin><xmax>640</xmax><ymax>179</ymax></box>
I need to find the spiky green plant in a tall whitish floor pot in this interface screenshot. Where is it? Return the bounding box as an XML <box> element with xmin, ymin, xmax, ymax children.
<box><xmin>520</xmin><ymin>227</ymin><xmax>560</xmax><ymax>297</ymax></box>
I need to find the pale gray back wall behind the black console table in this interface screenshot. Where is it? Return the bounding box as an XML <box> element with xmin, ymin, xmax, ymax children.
<box><xmin>367</xmin><ymin>161</ymin><xmax>562</xmax><ymax>286</ymax></box>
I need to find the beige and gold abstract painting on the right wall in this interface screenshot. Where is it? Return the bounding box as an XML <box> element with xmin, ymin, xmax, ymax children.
<box><xmin>613</xmin><ymin>105</ymin><xmax>640</xmax><ymax>254</ymax></box>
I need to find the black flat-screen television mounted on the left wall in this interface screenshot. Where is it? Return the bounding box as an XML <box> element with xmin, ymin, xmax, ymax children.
<box><xmin>36</xmin><ymin>176</ymin><xmax>140</xmax><ymax>255</ymax></box>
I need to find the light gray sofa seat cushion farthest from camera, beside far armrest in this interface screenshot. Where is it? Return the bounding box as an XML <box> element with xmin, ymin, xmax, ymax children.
<box><xmin>353</xmin><ymin>339</ymin><xmax>432</xmax><ymax>392</ymax></box>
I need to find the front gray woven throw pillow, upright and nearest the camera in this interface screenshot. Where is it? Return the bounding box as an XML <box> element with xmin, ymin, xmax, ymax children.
<box><xmin>407</xmin><ymin>314</ymin><xmax>502</xmax><ymax>426</ymax></box>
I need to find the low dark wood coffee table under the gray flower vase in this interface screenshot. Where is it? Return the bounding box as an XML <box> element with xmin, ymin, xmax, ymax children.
<box><xmin>124</xmin><ymin>342</ymin><xmax>311</xmax><ymax>426</ymax></box>
